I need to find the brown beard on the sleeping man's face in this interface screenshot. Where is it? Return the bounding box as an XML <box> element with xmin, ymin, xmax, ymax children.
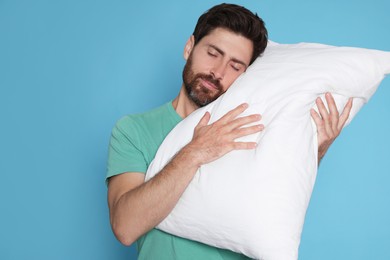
<box><xmin>183</xmin><ymin>55</ymin><xmax>224</xmax><ymax>107</ymax></box>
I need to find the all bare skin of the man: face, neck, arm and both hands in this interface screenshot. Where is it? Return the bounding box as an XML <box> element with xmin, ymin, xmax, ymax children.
<box><xmin>108</xmin><ymin>29</ymin><xmax>352</xmax><ymax>245</ymax></box>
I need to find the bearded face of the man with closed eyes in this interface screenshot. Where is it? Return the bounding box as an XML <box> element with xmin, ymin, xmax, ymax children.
<box><xmin>183</xmin><ymin>28</ymin><xmax>253</xmax><ymax>107</ymax></box>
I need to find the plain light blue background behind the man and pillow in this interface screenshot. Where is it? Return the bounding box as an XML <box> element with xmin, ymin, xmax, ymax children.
<box><xmin>0</xmin><ymin>0</ymin><xmax>390</xmax><ymax>260</ymax></box>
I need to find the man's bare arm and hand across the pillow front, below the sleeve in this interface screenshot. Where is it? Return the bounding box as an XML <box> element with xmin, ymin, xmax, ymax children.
<box><xmin>108</xmin><ymin>102</ymin><xmax>263</xmax><ymax>245</ymax></box>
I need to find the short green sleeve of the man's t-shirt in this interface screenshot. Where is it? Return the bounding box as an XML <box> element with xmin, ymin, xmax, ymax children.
<box><xmin>106</xmin><ymin>117</ymin><xmax>147</xmax><ymax>182</ymax></box>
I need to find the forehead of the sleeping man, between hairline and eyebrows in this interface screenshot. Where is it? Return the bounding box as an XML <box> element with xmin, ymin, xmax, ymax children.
<box><xmin>197</xmin><ymin>28</ymin><xmax>253</xmax><ymax>65</ymax></box>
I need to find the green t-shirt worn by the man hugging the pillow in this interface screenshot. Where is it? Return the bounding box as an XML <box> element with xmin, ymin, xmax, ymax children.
<box><xmin>107</xmin><ymin>102</ymin><xmax>248</xmax><ymax>260</ymax></box>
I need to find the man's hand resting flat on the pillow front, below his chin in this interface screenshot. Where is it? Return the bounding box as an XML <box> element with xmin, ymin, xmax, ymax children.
<box><xmin>186</xmin><ymin>104</ymin><xmax>264</xmax><ymax>166</ymax></box>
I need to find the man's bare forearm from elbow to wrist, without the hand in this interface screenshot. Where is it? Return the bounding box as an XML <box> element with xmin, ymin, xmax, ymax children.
<box><xmin>111</xmin><ymin>148</ymin><xmax>199</xmax><ymax>245</ymax></box>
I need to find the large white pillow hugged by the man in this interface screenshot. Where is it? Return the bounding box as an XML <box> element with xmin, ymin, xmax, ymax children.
<box><xmin>146</xmin><ymin>42</ymin><xmax>390</xmax><ymax>260</ymax></box>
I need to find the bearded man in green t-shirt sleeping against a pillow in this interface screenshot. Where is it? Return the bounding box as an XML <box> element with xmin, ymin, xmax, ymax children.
<box><xmin>107</xmin><ymin>4</ymin><xmax>352</xmax><ymax>260</ymax></box>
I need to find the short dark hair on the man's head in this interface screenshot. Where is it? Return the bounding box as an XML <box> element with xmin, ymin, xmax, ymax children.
<box><xmin>193</xmin><ymin>3</ymin><xmax>268</xmax><ymax>64</ymax></box>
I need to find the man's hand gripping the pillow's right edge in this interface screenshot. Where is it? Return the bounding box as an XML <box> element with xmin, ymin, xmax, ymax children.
<box><xmin>310</xmin><ymin>93</ymin><xmax>352</xmax><ymax>162</ymax></box>
